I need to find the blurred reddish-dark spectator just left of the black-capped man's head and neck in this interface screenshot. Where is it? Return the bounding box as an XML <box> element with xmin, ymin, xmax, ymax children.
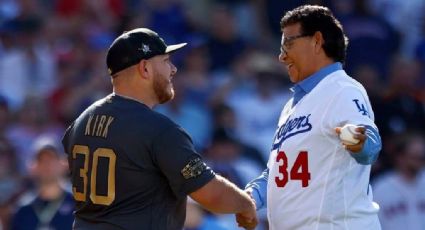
<box><xmin>48</xmin><ymin>40</ymin><xmax>111</xmax><ymax>125</ymax></box>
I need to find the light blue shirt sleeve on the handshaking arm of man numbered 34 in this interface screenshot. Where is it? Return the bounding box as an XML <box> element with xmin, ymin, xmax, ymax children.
<box><xmin>245</xmin><ymin>168</ymin><xmax>269</xmax><ymax>210</ymax></box>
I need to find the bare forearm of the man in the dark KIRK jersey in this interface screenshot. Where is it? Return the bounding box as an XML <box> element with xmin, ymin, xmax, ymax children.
<box><xmin>190</xmin><ymin>175</ymin><xmax>255</xmax><ymax>213</ymax></box>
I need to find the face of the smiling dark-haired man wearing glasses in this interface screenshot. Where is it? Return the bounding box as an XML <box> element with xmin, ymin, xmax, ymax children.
<box><xmin>279</xmin><ymin>23</ymin><xmax>314</xmax><ymax>83</ymax></box>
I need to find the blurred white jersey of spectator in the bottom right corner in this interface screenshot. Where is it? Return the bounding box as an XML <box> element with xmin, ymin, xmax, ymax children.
<box><xmin>373</xmin><ymin>171</ymin><xmax>425</xmax><ymax>230</ymax></box>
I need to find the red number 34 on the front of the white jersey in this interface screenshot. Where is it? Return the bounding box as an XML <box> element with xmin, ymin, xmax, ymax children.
<box><xmin>274</xmin><ymin>151</ymin><xmax>311</xmax><ymax>187</ymax></box>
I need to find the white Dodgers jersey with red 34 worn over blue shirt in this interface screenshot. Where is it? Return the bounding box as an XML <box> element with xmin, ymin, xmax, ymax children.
<box><xmin>267</xmin><ymin>70</ymin><xmax>380</xmax><ymax>230</ymax></box>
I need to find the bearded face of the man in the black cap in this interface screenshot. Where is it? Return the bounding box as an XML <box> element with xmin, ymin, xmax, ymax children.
<box><xmin>152</xmin><ymin>54</ymin><xmax>177</xmax><ymax>104</ymax></box>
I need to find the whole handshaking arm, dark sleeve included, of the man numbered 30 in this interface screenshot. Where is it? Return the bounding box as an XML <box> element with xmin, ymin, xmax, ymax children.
<box><xmin>153</xmin><ymin>126</ymin><xmax>257</xmax><ymax>228</ymax></box>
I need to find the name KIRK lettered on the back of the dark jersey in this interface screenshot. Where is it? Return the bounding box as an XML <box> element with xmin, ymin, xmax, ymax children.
<box><xmin>84</xmin><ymin>114</ymin><xmax>114</xmax><ymax>138</ymax></box>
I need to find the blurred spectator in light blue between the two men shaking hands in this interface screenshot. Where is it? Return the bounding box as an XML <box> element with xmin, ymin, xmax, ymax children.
<box><xmin>218</xmin><ymin>52</ymin><xmax>290</xmax><ymax>160</ymax></box>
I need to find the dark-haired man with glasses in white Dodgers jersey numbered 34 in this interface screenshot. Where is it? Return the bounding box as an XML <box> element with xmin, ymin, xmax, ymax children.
<box><xmin>236</xmin><ymin>5</ymin><xmax>381</xmax><ymax>230</ymax></box>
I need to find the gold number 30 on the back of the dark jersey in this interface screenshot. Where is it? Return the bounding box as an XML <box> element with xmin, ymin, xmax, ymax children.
<box><xmin>72</xmin><ymin>145</ymin><xmax>117</xmax><ymax>205</ymax></box>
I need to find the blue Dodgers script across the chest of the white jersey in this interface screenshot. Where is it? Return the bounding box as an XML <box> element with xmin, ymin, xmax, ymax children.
<box><xmin>272</xmin><ymin>114</ymin><xmax>313</xmax><ymax>150</ymax></box>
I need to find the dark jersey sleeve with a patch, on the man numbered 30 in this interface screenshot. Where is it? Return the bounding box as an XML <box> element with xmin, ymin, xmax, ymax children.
<box><xmin>152</xmin><ymin>126</ymin><xmax>215</xmax><ymax>197</ymax></box>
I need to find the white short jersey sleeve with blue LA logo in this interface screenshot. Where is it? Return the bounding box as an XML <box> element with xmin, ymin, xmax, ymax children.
<box><xmin>324</xmin><ymin>86</ymin><xmax>376</xmax><ymax>129</ymax></box>
